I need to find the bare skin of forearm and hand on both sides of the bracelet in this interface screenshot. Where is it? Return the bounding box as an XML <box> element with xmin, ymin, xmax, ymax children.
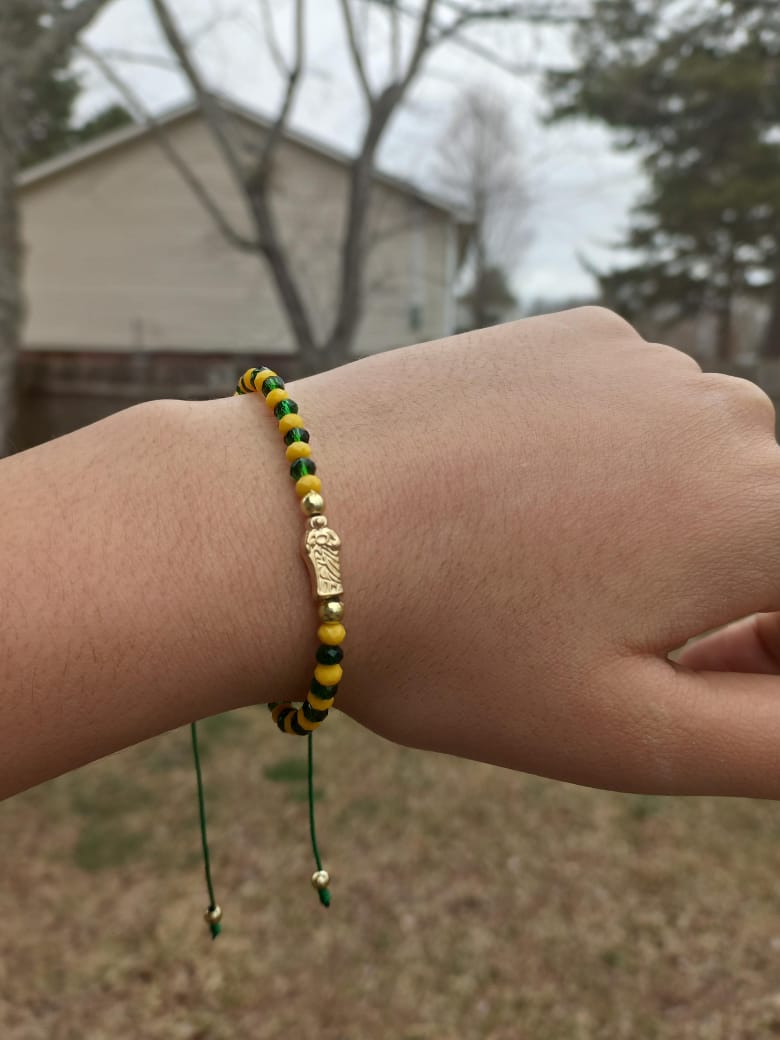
<box><xmin>0</xmin><ymin>308</ymin><xmax>780</xmax><ymax>798</ymax></box>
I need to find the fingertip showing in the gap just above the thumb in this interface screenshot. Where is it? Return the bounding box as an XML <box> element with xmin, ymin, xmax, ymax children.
<box><xmin>676</xmin><ymin>614</ymin><xmax>780</xmax><ymax>675</ymax></box>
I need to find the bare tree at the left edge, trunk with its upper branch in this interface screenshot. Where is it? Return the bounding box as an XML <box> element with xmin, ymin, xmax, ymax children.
<box><xmin>0</xmin><ymin>0</ymin><xmax>110</xmax><ymax>458</ymax></box>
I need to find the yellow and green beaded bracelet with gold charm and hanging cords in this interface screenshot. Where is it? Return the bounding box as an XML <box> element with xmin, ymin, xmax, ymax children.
<box><xmin>190</xmin><ymin>366</ymin><xmax>346</xmax><ymax>938</ymax></box>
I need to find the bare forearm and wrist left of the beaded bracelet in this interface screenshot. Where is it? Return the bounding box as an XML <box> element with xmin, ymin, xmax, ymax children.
<box><xmin>0</xmin><ymin>395</ymin><xmax>336</xmax><ymax>797</ymax></box>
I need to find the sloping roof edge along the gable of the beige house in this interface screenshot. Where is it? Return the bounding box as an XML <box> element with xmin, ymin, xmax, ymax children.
<box><xmin>18</xmin><ymin>96</ymin><xmax>463</xmax><ymax>223</ymax></box>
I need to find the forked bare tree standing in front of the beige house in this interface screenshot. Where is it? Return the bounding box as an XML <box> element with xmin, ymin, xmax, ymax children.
<box><xmin>92</xmin><ymin>0</ymin><xmax>576</xmax><ymax>372</ymax></box>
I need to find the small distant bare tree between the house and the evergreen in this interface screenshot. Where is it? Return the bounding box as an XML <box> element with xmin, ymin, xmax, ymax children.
<box><xmin>434</xmin><ymin>86</ymin><xmax>529</xmax><ymax>329</ymax></box>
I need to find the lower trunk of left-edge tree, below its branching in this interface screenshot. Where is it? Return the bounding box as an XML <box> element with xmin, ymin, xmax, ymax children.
<box><xmin>0</xmin><ymin>111</ymin><xmax>23</xmax><ymax>459</ymax></box>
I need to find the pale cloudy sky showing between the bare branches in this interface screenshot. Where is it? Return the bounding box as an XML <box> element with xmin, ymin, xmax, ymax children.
<box><xmin>80</xmin><ymin>0</ymin><xmax>643</xmax><ymax>306</ymax></box>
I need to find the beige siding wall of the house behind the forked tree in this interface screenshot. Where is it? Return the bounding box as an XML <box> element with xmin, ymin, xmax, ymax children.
<box><xmin>22</xmin><ymin>115</ymin><xmax>451</xmax><ymax>354</ymax></box>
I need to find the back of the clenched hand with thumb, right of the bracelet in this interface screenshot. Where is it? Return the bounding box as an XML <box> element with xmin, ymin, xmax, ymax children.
<box><xmin>291</xmin><ymin>308</ymin><xmax>780</xmax><ymax>798</ymax></box>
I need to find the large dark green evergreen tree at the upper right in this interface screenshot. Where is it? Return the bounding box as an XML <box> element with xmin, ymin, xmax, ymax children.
<box><xmin>550</xmin><ymin>0</ymin><xmax>780</xmax><ymax>360</ymax></box>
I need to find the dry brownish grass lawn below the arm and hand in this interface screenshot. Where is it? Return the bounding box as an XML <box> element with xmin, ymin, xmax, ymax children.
<box><xmin>0</xmin><ymin>709</ymin><xmax>780</xmax><ymax>1040</ymax></box>
